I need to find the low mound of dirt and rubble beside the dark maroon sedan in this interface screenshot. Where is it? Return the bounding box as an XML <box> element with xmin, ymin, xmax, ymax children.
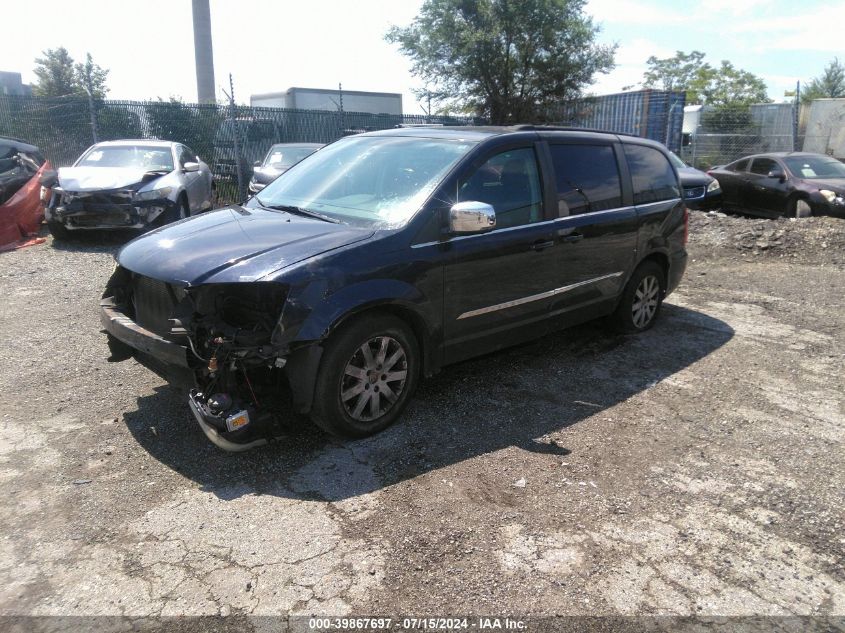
<box><xmin>690</xmin><ymin>211</ymin><xmax>845</xmax><ymax>264</ymax></box>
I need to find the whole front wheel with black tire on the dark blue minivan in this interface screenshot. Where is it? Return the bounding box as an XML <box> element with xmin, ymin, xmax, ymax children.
<box><xmin>311</xmin><ymin>314</ymin><xmax>420</xmax><ymax>438</ymax></box>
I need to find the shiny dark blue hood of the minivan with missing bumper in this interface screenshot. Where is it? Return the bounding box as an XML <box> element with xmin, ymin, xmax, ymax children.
<box><xmin>117</xmin><ymin>205</ymin><xmax>374</xmax><ymax>285</ymax></box>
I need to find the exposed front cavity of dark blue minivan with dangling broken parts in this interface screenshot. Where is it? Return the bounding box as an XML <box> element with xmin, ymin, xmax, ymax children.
<box><xmin>101</xmin><ymin>267</ymin><xmax>296</xmax><ymax>451</ymax></box>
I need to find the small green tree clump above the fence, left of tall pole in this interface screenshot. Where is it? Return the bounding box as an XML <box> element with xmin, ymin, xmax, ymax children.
<box><xmin>32</xmin><ymin>46</ymin><xmax>109</xmax><ymax>99</ymax></box>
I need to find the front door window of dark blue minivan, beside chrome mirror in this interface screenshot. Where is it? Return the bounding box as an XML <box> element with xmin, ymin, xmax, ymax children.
<box><xmin>458</xmin><ymin>147</ymin><xmax>543</xmax><ymax>228</ymax></box>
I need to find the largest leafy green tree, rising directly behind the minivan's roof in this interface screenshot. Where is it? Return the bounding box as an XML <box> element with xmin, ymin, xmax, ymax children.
<box><xmin>385</xmin><ymin>0</ymin><xmax>616</xmax><ymax>125</ymax></box>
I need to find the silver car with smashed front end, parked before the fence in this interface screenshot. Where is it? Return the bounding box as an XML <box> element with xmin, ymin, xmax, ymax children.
<box><xmin>45</xmin><ymin>140</ymin><xmax>212</xmax><ymax>239</ymax></box>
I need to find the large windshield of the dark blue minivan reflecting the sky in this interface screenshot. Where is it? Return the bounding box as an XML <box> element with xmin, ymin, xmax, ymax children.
<box><xmin>248</xmin><ymin>136</ymin><xmax>474</xmax><ymax>228</ymax></box>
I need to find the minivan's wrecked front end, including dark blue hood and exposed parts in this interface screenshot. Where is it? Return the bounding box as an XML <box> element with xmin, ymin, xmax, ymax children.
<box><xmin>100</xmin><ymin>205</ymin><xmax>373</xmax><ymax>451</ymax></box>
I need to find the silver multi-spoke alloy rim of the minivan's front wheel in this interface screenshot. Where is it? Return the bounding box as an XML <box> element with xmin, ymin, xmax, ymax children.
<box><xmin>340</xmin><ymin>336</ymin><xmax>408</xmax><ymax>422</ymax></box>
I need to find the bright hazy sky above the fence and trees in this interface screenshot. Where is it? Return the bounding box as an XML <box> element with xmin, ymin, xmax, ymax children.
<box><xmin>0</xmin><ymin>0</ymin><xmax>845</xmax><ymax>114</ymax></box>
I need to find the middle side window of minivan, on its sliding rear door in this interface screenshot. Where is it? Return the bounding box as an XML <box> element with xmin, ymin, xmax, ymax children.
<box><xmin>550</xmin><ymin>145</ymin><xmax>622</xmax><ymax>217</ymax></box>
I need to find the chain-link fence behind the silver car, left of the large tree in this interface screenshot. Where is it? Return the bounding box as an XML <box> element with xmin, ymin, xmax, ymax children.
<box><xmin>0</xmin><ymin>96</ymin><xmax>483</xmax><ymax>201</ymax></box>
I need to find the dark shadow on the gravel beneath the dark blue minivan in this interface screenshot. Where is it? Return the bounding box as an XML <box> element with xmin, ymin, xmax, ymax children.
<box><xmin>124</xmin><ymin>304</ymin><xmax>734</xmax><ymax>501</ymax></box>
